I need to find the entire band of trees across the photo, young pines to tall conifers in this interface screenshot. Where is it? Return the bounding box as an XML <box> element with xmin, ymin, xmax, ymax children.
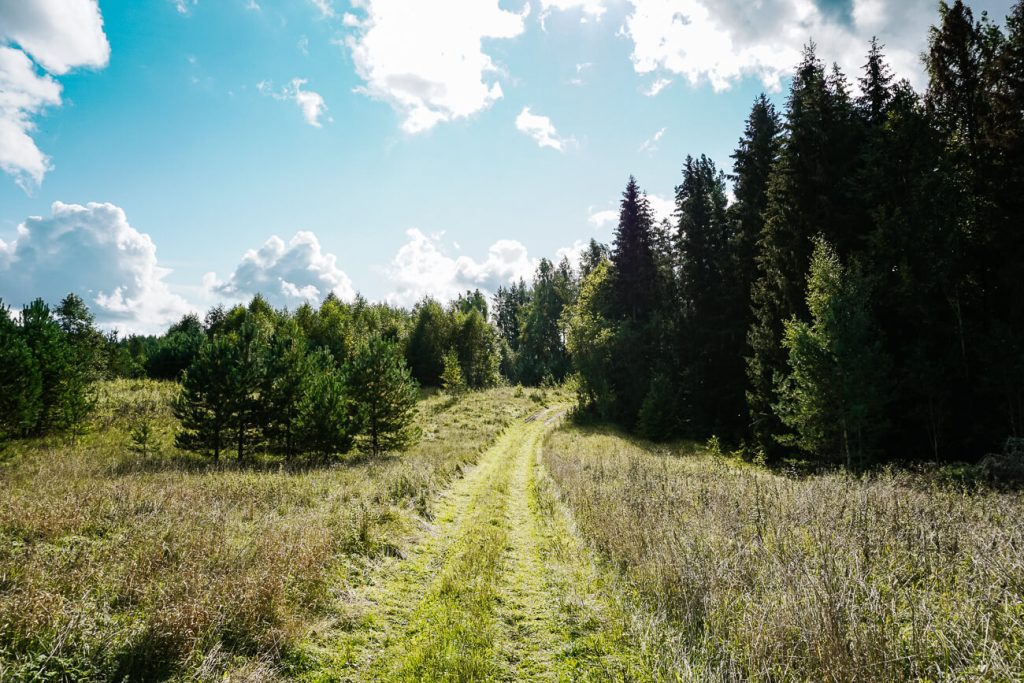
<box><xmin>0</xmin><ymin>2</ymin><xmax>1024</xmax><ymax>468</ymax></box>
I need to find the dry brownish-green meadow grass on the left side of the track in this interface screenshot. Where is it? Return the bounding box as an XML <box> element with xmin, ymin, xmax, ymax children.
<box><xmin>0</xmin><ymin>381</ymin><xmax>537</xmax><ymax>681</ymax></box>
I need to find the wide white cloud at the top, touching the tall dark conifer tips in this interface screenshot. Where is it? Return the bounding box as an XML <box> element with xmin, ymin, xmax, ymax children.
<box><xmin>624</xmin><ymin>0</ymin><xmax>950</xmax><ymax>94</ymax></box>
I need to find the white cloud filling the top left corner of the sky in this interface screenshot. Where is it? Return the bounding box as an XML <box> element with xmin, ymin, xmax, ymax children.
<box><xmin>0</xmin><ymin>0</ymin><xmax>111</xmax><ymax>191</ymax></box>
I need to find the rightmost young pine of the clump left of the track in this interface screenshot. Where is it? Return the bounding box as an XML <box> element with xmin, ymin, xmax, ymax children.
<box><xmin>348</xmin><ymin>335</ymin><xmax>419</xmax><ymax>456</ymax></box>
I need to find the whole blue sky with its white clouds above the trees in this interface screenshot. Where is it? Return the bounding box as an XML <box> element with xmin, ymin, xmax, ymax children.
<box><xmin>0</xmin><ymin>0</ymin><xmax>1011</xmax><ymax>333</ymax></box>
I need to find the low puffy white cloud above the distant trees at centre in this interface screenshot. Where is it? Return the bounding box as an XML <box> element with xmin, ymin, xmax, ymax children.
<box><xmin>385</xmin><ymin>227</ymin><xmax>538</xmax><ymax>305</ymax></box>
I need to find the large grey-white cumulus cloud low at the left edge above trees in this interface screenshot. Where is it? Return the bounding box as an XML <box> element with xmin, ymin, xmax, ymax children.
<box><xmin>0</xmin><ymin>202</ymin><xmax>189</xmax><ymax>332</ymax></box>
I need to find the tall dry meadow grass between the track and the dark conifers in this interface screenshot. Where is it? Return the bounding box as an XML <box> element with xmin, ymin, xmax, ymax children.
<box><xmin>544</xmin><ymin>427</ymin><xmax>1024</xmax><ymax>681</ymax></box>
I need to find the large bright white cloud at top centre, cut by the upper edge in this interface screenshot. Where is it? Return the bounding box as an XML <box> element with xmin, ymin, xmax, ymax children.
<box><xmin>343</xmin><ymin>0</ymin><xmax>529</xmax><ymax>134</ymax></box>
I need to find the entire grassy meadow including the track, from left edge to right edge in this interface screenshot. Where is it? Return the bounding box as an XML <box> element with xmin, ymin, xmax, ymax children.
<box><xmin>0</xmin><ymin>381</ymin><xmax>1024</xmax><ymax>682</ymax></box>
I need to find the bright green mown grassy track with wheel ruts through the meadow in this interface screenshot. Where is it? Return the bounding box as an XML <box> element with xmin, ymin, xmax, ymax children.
<box><xmin>299</xmin><ymin>409</ymin><xmax>640</xmax><ymax>681</ymax></box>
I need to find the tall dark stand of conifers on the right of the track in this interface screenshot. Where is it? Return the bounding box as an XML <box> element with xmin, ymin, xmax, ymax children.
<box><xmin>565</xmin><ymin>1</ymin><xmax>1024</xmax><ymax>465</ymax></box>
